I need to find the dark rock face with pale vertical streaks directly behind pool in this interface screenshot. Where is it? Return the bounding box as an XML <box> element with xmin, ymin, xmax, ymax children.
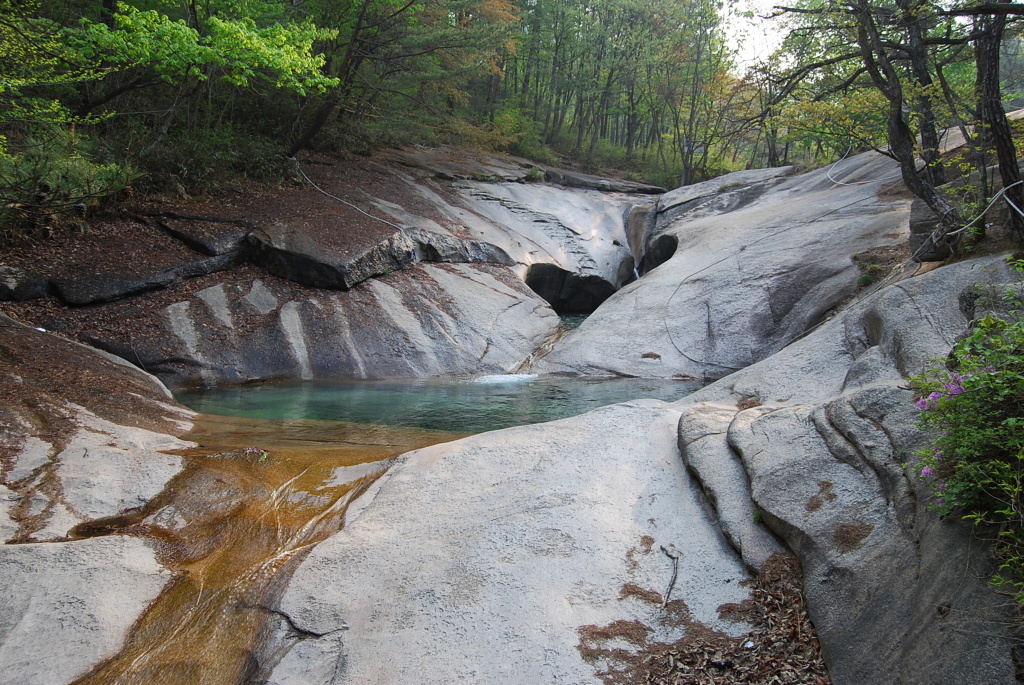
<box><xmin>56</xmin><ymin>264</ymin><xmax>559</xmax><ymax>386</ymax></box>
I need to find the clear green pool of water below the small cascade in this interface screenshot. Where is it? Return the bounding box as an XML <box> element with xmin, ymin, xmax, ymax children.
<box><xmin>178</xmin><ymin>375</ymin><xmax>699</xmax><ymax>433</ymax></box>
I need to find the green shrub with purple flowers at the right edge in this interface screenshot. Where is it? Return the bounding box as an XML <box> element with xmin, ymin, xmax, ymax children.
<box><xmin>907</xmin><ymin>314</ymin><xmax>1024</xmax><ymax>604</ymax></box>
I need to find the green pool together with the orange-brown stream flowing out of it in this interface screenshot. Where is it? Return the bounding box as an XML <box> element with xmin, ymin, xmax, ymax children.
<box><xmin>72</xmin><ymin>375</ymin><xmax>696</xmax><ymax>685</ymax></box>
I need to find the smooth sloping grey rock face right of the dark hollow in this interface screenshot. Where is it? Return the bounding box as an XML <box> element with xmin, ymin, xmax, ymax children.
<box><xmin>536</xmin><ymin>154</ymin><xmax>909</xmax><ymax>379</ymax></box>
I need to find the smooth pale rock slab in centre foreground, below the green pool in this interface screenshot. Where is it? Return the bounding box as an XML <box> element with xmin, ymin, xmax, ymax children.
<box><xmin>267</xmin><ymin>400</ymin><xmax>750</xmax><ymax>685</ymax></box>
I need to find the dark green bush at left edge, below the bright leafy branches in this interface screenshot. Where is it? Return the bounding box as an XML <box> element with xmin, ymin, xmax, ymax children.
<box><xmin>0</xmin><ymin>128</ymin><xmax>138</xmax><ymax>244</ymax></box>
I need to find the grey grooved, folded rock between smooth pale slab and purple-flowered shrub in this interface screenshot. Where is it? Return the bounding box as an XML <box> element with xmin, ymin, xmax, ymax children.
<box><xmin>676</xmin><ymin>253</ymin><xmax>1016</xmax><ymax>685</ymax></box>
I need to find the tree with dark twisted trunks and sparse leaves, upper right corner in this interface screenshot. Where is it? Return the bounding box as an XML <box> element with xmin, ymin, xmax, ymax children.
<box><xmin>778</xmin><ymin>0</ymin><xmax>1024</xmax><ymax>244</ymax></box>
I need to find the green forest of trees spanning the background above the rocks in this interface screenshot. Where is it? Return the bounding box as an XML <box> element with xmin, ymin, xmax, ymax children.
<box><xmin>6</xmin><ymin>0</ymin><xmax>1024</xmax><ymax>248</ymax></box>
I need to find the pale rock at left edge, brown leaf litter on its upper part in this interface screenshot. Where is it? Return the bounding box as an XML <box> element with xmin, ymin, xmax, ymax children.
<box><xmin>0</xmin><ymin>315</ymin><xmax>194</xmax><ymax>685</ymax></box>
